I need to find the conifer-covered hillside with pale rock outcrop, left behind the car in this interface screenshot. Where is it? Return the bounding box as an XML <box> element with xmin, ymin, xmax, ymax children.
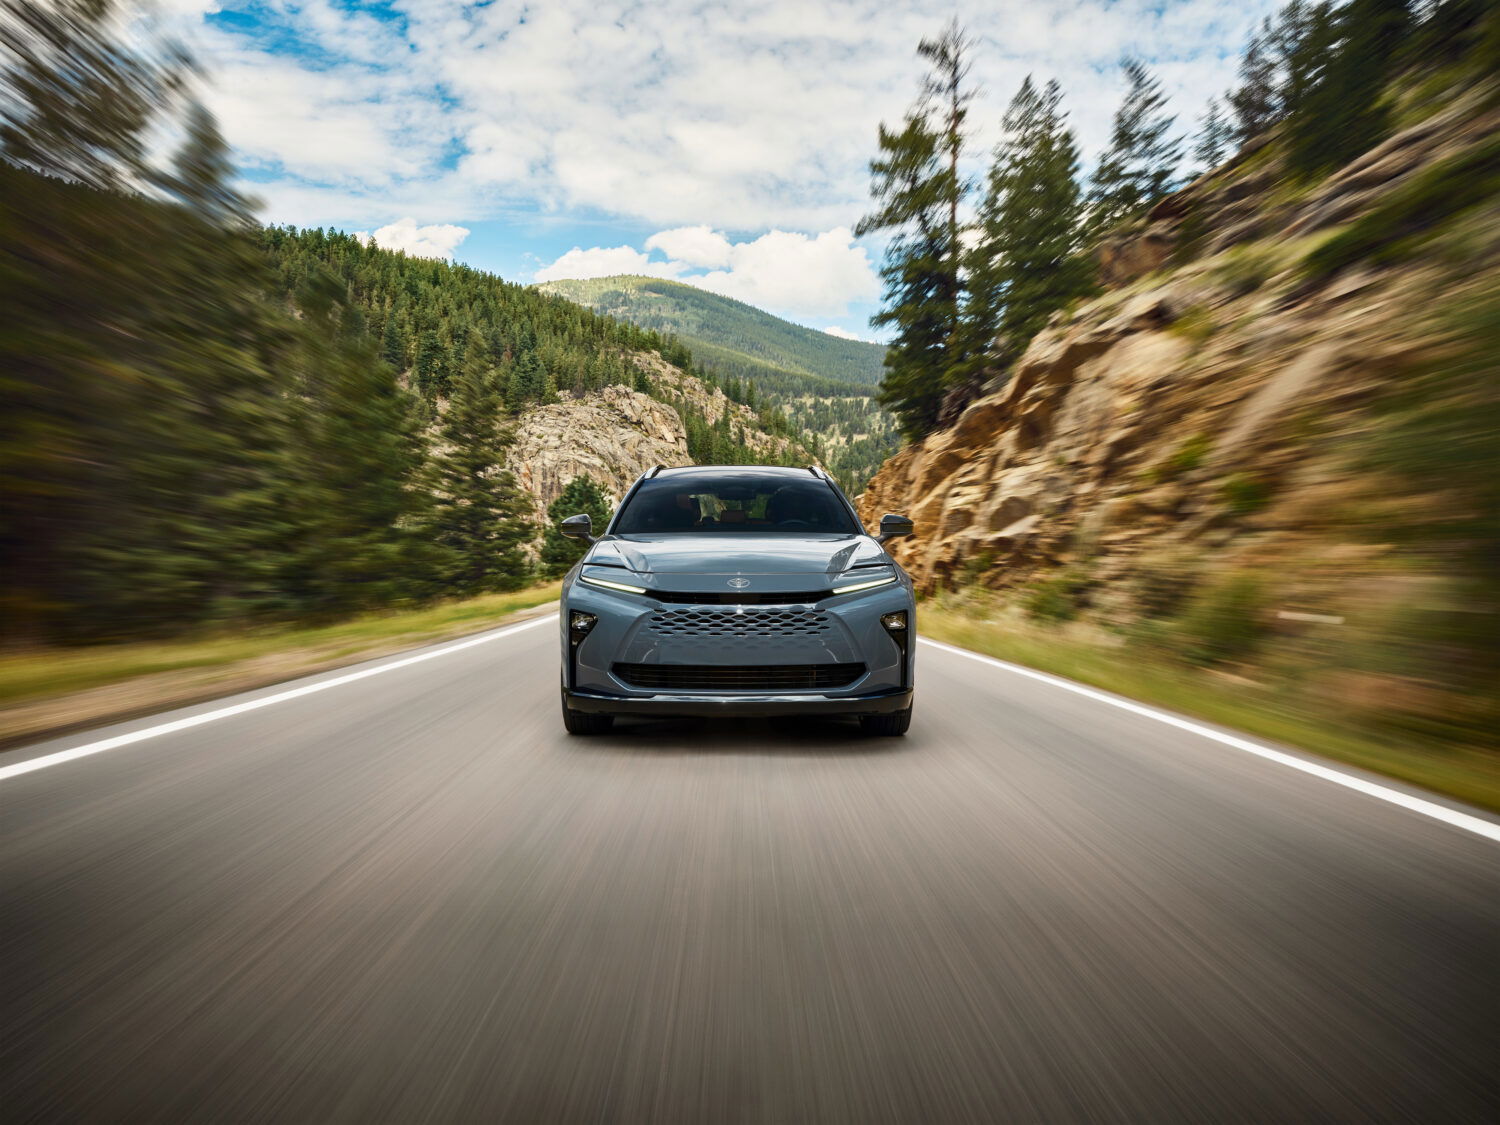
<box><xmin>261</xmin><ymin>228</ymin><xmax>815</xmax><ymax>492</ymax></box>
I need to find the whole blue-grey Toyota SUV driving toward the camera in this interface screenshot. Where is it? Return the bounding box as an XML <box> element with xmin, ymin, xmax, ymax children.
<box><xmin>561</xmin><ymin>467</ymin><xmax>917</xmax><ymax>735</ymax></box>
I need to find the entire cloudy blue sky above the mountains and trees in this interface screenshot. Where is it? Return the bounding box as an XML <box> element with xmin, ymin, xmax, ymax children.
<box><xmin>162</xmin><ymin>0</ymin><xmax>1275</xmax><ymax>339</ymax></box>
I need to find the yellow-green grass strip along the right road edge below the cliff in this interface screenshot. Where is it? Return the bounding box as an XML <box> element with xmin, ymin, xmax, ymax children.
<box><xmin>918</xmin><ymin>602</ymin><xmax>1500</xmax><ymax>812</ymax></box>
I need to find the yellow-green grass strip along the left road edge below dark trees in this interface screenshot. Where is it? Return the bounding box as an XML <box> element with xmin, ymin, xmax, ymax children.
<box><xmin>0</xmin><ymin>582</ymin><xmax>561</xmax><ymax>707</ymax></box>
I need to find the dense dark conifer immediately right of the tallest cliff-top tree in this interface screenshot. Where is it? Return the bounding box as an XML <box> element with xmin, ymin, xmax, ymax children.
<box><xmin>965</xmin><ymin>77</ymin><xmax>1094</xmax><ymax>375</ymax></box>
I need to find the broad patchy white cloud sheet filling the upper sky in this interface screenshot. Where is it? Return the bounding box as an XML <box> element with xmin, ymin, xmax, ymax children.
<box><xmin>190</xmin><ymin>0</ymin><xmax>1280</xmax><ymax>234</ymax></box>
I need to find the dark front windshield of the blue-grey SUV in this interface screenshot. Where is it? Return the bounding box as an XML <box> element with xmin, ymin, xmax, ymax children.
<box><xmin>615</xmin><ymin>473</ymin><xmax>860</xmax><ymax>536</ymax></box>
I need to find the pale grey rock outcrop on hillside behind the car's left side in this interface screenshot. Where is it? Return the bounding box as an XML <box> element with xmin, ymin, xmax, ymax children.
<box><xmin>509</xmin><ymin>353</ymin><xmax>812</xmax><ymax>512</ymax></box>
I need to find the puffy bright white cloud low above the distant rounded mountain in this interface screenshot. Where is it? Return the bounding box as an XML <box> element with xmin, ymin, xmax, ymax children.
<box><xmin>536</xmin><ymin>227</ymin><xmax>879</xmax><ymax>321</ymax></box>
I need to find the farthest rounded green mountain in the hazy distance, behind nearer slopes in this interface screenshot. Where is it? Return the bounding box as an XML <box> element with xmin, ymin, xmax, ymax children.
<box><xmin>537</xmin><ymin>275</ymin><xmax>897</xmax><ymax>492</ymax></box>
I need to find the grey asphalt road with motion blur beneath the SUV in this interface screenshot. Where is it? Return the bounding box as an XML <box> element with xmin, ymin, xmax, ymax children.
<box><xmin>0</xmin><ymin>624</ymin><xmax>1500</xmax><ymax>1122</ymax></box>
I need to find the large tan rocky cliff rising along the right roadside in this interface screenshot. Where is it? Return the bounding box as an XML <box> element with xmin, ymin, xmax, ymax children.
<box><xmin>860</xmin><ymin>92</ymin><xmax>1500</xmax><ymax>618</ymax></box>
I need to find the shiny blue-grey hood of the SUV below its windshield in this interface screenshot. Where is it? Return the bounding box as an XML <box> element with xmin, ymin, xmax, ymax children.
<box><xmin>584</xmin><ymin>533</ymin><xmax>891</xmax><ymax>579</ymax></box>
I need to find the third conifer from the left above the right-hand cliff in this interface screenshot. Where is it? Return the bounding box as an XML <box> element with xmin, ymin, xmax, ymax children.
<box><xmin>1089</xmin><ymin>59</ymin><xmax>1182</xmax><ymax>231</ymax></box>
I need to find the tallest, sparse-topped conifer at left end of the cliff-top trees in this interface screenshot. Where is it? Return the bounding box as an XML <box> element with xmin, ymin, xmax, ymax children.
<box><xmin>857</xmin><ymin>24</ymin><xmax>972</xmax><ymax>438</ymax></box>
